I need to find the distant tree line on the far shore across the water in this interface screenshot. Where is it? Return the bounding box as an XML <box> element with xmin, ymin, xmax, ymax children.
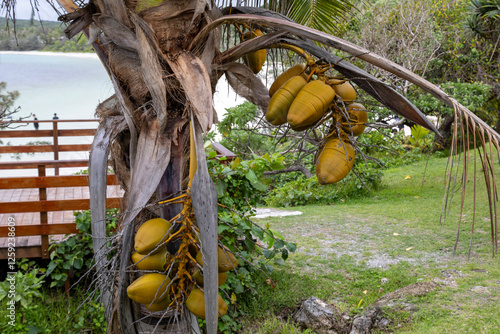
<box><xmin>0</xmin><ymin>18</ymin><xmax>93</xmax><ymax>52</ymax></box>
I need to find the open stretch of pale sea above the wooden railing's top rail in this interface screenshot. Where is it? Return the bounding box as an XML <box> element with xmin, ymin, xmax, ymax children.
<box><xmin>0</xmin><ymin>53</ymin><xmax>113</xmax><ymax>124</ymax></box>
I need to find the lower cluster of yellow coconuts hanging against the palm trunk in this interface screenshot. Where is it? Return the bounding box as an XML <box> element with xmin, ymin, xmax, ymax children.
<box><xmin>127</xmin><ymin>218</ymin><xmax>238</xmax><ymax>319</ymax></box>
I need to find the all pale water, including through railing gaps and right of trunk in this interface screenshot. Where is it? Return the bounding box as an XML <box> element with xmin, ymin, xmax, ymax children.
<box><xmin>0</xmin><ymin>52</ymin><xmax>244</xmax><ymax>177</ymax></box>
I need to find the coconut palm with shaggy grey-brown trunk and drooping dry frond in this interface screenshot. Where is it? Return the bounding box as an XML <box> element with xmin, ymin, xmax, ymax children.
<box><xmin>2</xmin><ymin>0</ymin><xmax>500</xmax><ymax>334</ymax></box>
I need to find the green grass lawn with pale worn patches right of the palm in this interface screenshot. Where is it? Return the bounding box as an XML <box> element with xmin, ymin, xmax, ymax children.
<box><xmin>247</xmin><ymin>153</ymin><xmax>500</xmax><ymax>333</ymax></box>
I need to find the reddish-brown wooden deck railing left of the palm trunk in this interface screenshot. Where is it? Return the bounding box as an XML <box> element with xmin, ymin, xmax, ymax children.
<box><xmin>0</xmin><ymin>120</ymin><xmax>121</xmax><ymax>259</ymax></box>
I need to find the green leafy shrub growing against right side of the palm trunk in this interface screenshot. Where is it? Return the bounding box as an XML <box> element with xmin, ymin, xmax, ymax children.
<box><xmin>206</xmin><ymin>152</ymin><xmax>297</xmax><ymax>333</ymax></box>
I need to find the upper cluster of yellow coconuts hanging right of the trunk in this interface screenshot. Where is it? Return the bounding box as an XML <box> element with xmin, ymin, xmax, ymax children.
<box><xmin>266</xmin><ymin>64</ymin><xmax>368</xmax><ymax>184</ymax></box>
